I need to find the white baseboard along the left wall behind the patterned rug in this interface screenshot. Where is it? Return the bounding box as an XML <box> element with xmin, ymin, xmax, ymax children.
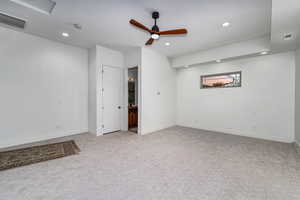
<box><xmin>0</xmin><ymin>128</ymin><xmax>88</xmax><ymax>149</ymax></box>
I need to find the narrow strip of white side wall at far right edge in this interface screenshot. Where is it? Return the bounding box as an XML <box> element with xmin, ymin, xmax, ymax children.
<box><xmin>295</xmin><ymin>49</ymin><xmax>300</xmax><ymax>145</ymax></box>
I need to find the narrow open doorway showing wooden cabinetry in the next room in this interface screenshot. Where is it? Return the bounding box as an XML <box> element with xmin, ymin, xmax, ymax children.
<box><xmin>128</xmin><ymin>67</ymin><xmax>138</xmax><ymax>133</ymax></box>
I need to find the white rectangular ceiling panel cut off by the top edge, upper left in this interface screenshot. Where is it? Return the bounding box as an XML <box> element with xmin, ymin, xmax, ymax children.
<box><xmin>10</xmin><ymin>0</ymin><xmax>56</xmax><ymax>15</ymax></box>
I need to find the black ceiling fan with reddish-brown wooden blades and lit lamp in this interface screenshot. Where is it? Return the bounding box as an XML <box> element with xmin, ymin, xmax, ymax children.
<box><xmin>129</xmin><ymin>12</ymin><xmax>187</xmax><ymax>45</ymax></box>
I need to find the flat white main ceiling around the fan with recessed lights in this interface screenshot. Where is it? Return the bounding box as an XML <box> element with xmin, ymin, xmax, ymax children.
<box><xmin>0</xmin><ymin>0</ymin><xmax>271</xmax><ymax>57</ymax></box>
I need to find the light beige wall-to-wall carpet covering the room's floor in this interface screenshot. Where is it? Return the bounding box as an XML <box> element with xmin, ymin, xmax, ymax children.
<box><xmin>0</xmin><ymin>127</ymin><xmax>300</xmax><ymax>200</ymax></box>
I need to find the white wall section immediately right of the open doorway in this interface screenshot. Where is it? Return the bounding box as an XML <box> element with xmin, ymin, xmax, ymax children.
<box><xmin>139</xmin><ymin>47</ymin><xmax>176</xmax><ymax>134</ymax></box>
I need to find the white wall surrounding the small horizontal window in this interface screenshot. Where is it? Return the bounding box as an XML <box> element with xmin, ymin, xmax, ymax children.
<box><xmin>176</xmin><ymin>52</ymin><xmax>295</xmax><ymax>142</ymax></box>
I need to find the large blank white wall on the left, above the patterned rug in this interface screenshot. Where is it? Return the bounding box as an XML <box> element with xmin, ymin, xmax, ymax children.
<box><xmin>0</xmin><ymin>27</ymin><xmax>88</xmax><ymax>148</ymax></box>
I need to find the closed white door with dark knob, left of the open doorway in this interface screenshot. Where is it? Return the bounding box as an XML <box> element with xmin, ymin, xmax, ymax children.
<box><xmin>102</xmin><ymin>66</ymin><xmax>122</xmax><ymax>134</ymax></box>
